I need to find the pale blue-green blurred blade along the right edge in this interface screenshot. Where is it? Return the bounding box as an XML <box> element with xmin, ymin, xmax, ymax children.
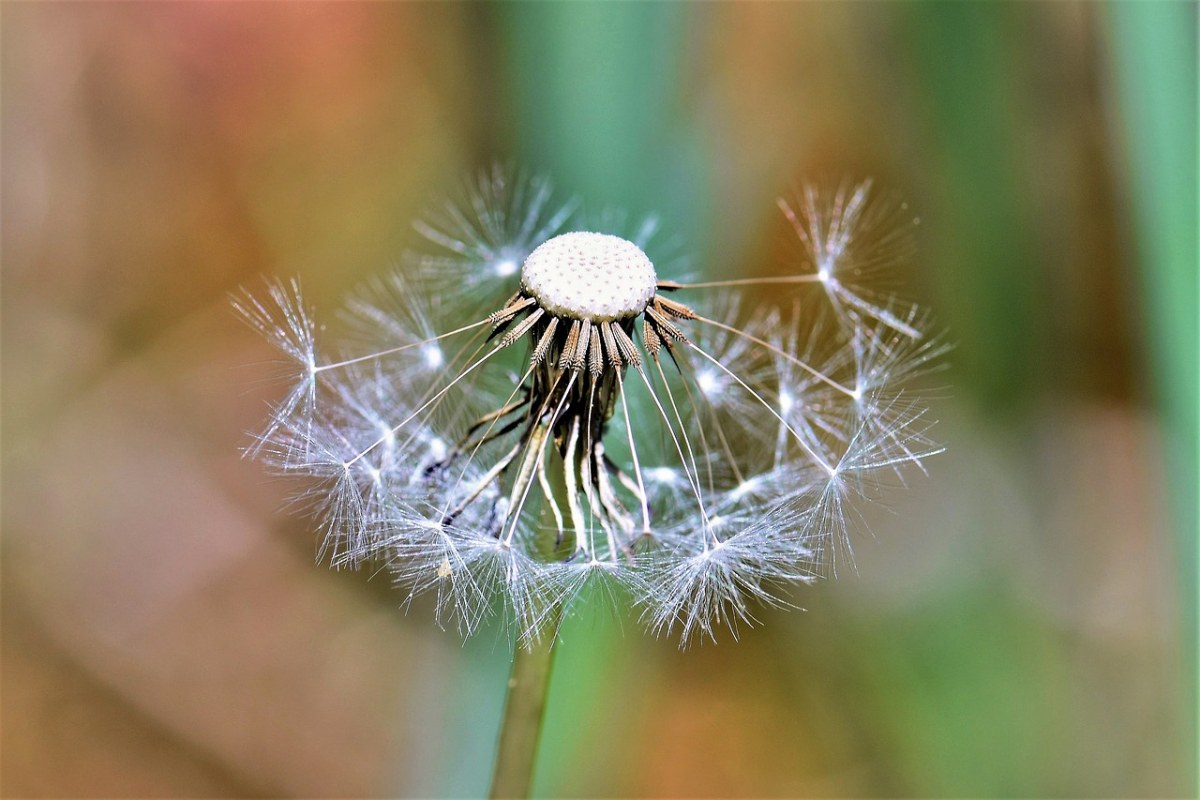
<box><xmin>1111</xmin><ymin>2</ymin><xmax>1200</xmax><ymax>757</ymax></box>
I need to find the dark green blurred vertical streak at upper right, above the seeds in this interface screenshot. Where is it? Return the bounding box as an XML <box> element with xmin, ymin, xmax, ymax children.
<box><xmin>901</xmin><ymin>2</ymin><xmax>1049</xmax><ymax>415</ymax></box>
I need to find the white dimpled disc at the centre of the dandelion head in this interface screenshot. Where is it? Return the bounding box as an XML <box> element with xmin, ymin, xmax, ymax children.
<box><xmin>521</xmin><ymin>231</ymin><xmax>658</xmax><ymax>323</ymax></box>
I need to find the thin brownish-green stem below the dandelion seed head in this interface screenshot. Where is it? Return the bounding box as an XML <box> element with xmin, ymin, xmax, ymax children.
<box><xmin>491</xmin><ymin>607</ymin><xmax>563</xmax><ymax>798</ymax></box>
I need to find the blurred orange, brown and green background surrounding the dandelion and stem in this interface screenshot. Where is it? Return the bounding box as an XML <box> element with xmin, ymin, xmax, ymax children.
<box><xmin>0</xmin><ymin>2</ymin><xmax>1198</xmax><ymax>796</ymax></box>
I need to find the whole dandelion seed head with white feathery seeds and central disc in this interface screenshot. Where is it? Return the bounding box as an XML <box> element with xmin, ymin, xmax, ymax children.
<box><xmin>235</xmin><ymin>168</ymin><xmax>944</xmax><ymax>642</ymax></box>
